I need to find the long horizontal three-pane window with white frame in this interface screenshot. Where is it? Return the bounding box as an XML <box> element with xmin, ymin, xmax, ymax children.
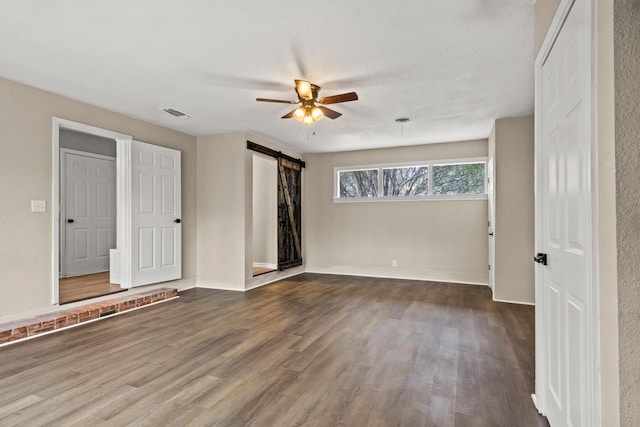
<box><xmin>334</xmin><ymin>158</ymin><xmax>486</xmax><ymax>201</ymax></box>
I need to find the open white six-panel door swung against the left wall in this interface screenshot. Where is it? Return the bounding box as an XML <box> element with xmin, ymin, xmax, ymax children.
<box><xmin>130</xmin><ymin>141</ymin><xmax>182</xmax><ymax>286</ymax></box>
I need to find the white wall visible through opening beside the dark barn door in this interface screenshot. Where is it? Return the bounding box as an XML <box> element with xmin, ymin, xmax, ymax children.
<box><xmin>252</xmin><ymin>153</ymin><xmax>278</xmax><ymax>265</ymax></box>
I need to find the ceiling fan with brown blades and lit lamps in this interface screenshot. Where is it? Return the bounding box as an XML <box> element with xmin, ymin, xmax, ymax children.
<box><xmin>256</xmin><ymin>80</ymin><xmax>358</xmax><ymax>125</ymax></box>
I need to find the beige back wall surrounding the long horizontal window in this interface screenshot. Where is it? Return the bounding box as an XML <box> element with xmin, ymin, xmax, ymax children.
<box><xmin>303</xmin><ymin>140</ymin><xmax>488</xmax><ymax>284</ymax></box>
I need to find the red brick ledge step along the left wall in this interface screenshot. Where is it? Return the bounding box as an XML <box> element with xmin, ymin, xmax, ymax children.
<box><xmin>0</xmin><ymin>288</ymin><xmax>178</xmax><ymax>346</ymax></box>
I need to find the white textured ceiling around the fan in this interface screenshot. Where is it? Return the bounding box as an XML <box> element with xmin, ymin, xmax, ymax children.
<box><xmin>0</xmin><ymin>0</ymin><xmax>533</xmax><ymax>152</ymax></box>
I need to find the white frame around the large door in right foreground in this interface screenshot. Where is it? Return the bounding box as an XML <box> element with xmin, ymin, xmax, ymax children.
<box><xmin>532</xmin><ymin>0</ymin><xmax>601</xmax><ymax>426</ymax></box>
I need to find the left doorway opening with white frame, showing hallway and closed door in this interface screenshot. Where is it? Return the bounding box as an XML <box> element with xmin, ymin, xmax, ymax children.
<box><xmin>52</xmin><ymin>118</ymin><xmax>131</xmax><ymax>304</ymax></box>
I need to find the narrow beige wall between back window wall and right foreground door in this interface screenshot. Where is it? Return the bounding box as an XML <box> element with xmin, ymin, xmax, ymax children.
<box><xmin>489</xmin><ymin>115</ymin><xmax>535</xmax><ymax>304</ymax></box>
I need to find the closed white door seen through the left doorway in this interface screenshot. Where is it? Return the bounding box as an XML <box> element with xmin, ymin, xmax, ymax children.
<box><xmin>62</xmin><ymin>151</ymin><xmax>116</xmax><ymax>277</ymax></box>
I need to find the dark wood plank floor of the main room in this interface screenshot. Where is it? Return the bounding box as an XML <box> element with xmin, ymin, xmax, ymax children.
<box><xmin>0</xmin><ymin>274</ymin><xmax>547</xmax><ymax>427</ymax></box>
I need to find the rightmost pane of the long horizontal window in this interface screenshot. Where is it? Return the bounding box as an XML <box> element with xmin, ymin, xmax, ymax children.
<box><xmin>433</xmin><ymin>162</ymin><xmax>485</xmax><ymax>194</ymax></box>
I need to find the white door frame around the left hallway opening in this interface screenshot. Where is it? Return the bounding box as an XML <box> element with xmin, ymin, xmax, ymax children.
<box><xmin>51</xmin><ymin>117</ymin><xmax>133</xmax><ymax>304</ymax></box>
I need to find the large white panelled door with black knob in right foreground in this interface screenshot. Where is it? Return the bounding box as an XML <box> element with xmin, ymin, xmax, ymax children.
<box><xmin>536</xmin><ymin>0</ymin><xmax>596</xmax><ymax>427</ymax></box>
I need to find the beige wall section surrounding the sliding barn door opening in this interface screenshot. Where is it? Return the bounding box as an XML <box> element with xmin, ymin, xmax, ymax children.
<box><xmin>197</xmin><ymin>132</ymin><xmax>304</xmax><ymax>291</ymax></box>
